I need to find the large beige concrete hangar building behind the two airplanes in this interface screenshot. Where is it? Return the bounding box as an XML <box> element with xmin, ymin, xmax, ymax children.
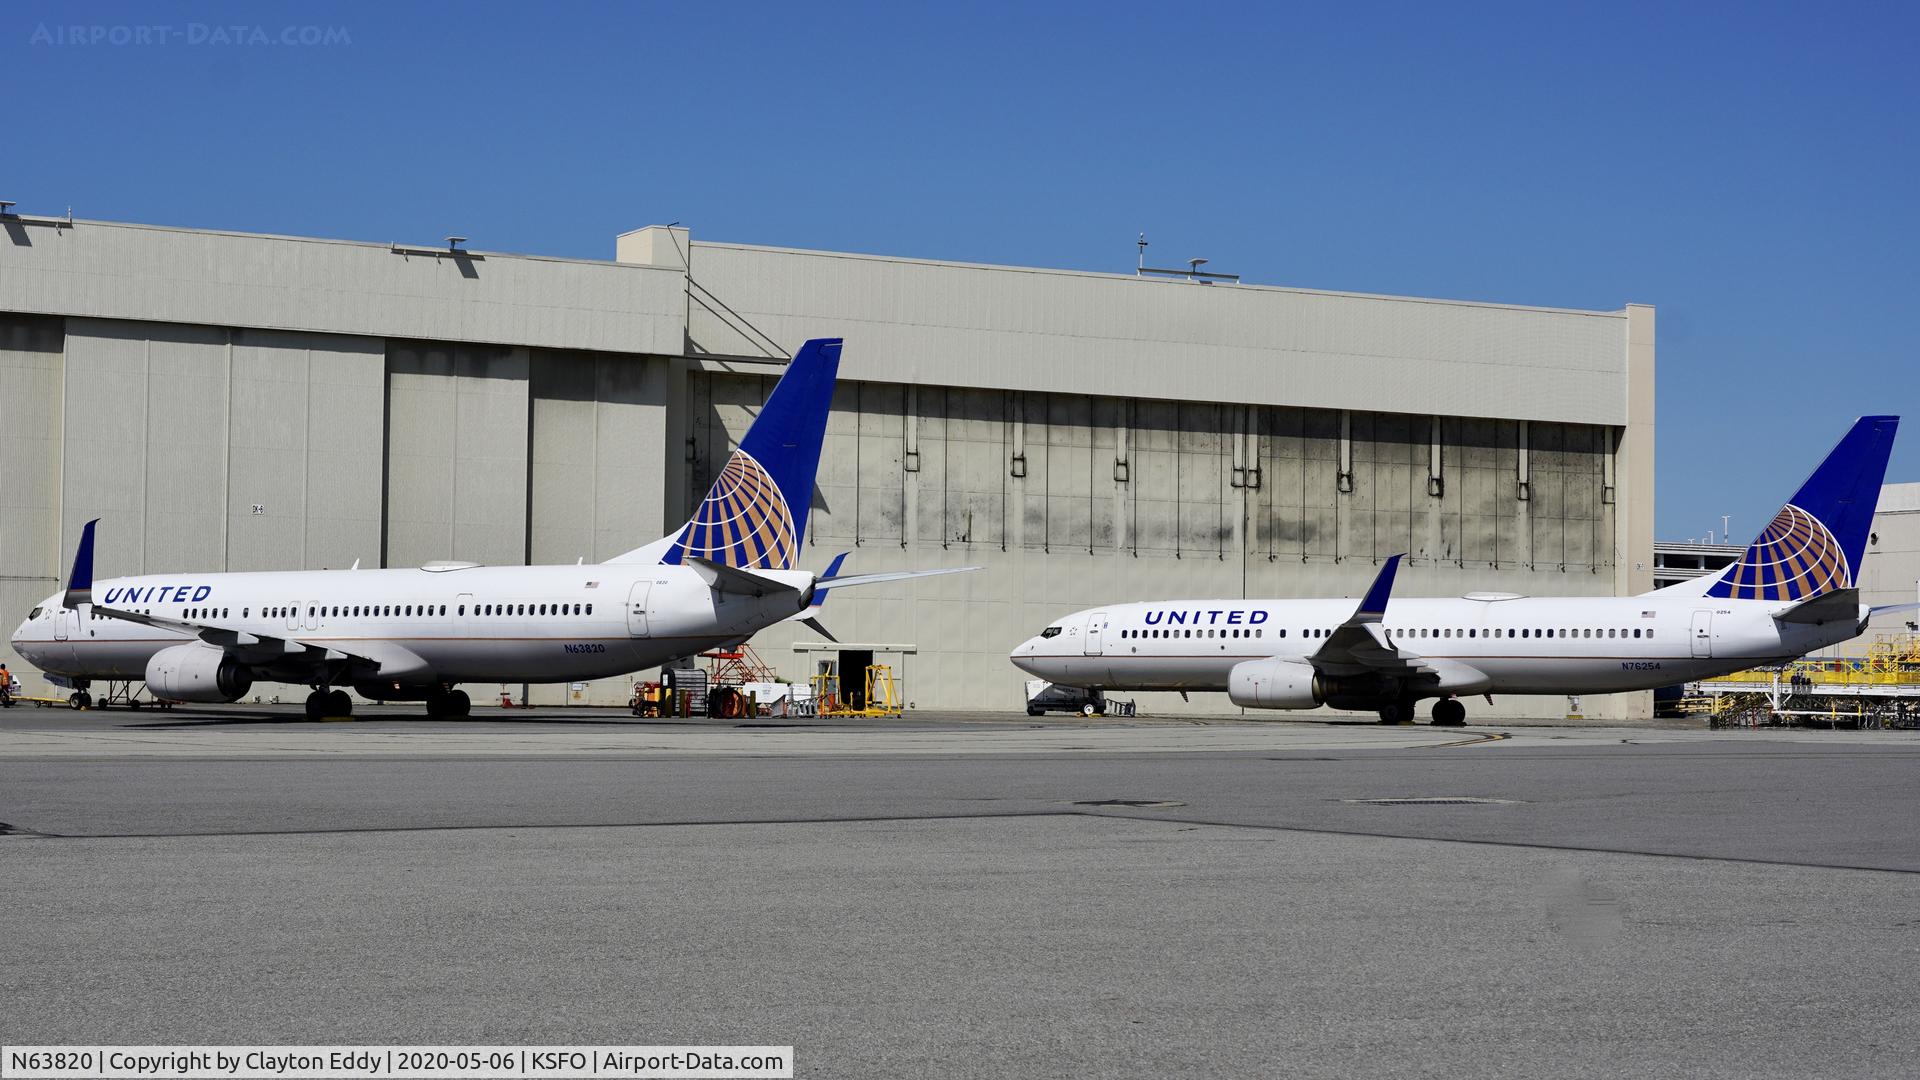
<box><xmin>0</xmin><ymin>213</ymin><xmax>1653</xmax><ymax>715</ymax></box>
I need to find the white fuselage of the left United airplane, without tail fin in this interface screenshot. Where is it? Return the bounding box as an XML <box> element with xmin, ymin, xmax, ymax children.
<box><xmin>13</xmin><ymin>563</ymin><xmax>812</xmax><ymax>684</ymax></box>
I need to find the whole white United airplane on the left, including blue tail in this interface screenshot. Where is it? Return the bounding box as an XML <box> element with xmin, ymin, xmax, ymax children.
<box><xmin>13</xmin><ymin>338</ymin><xmax>979</xmax><ymax>717</ymax></box>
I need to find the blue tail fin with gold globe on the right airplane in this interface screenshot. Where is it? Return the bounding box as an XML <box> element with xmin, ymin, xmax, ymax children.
<box><xmin>1707</xmin><ymin>417</ymin><xmax>1901</xmax><ymax>600</ymax></box>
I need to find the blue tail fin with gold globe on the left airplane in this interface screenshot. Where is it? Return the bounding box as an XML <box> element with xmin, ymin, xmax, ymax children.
<box><xmin>609</xmin><ymin>338</ymin><xmax>841</xmax><ymax>571</ymax></box>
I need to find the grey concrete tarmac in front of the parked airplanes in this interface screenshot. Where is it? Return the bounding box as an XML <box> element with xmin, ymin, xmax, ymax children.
<box><xmin>0</xmin><ymin>709</ymin><xmax>1920</xmax><ymax>1076</ymax></box>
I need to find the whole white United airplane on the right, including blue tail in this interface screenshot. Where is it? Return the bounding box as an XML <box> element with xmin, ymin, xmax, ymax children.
<box><xmin>1010</xmin><ymin>417</ymin><xmax>1914</xmax><ymax>726</ymax></box>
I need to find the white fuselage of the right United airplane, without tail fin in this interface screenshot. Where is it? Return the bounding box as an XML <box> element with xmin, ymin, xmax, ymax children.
<box><xmin>1010</xmin><ymin>596</ymin><xmax>1864</xmax><ymax>694</ymax></box>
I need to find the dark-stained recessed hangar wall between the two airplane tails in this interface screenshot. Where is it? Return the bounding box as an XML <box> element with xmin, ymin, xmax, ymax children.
<box><xmin>680</xmin><ymin>371</ymin><xmax>1634</xmax><ymax>715</ymax></box>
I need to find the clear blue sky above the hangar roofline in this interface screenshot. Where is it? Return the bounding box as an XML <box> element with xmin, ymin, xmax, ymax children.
<box><xmin>0</xmin><ymin>4</ymin><xmax>1920</xmax><ymax>538</ymax></box>
